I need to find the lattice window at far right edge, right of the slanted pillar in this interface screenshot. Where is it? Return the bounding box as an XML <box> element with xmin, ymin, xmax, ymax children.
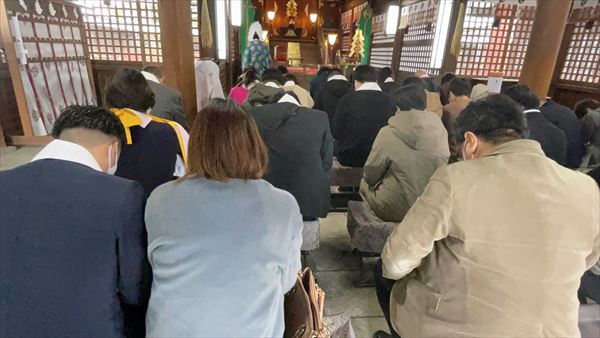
<box><xmin>560</xmin><ymin>21</ymin><xmax>600</xmax><ymax>85</ymax></box>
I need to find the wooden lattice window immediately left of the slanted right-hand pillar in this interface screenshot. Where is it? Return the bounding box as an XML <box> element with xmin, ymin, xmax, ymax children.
<box><xmin>456</xmin><ymin>1</ymin><xmax>535</xmax><ymax>79</ymax></box>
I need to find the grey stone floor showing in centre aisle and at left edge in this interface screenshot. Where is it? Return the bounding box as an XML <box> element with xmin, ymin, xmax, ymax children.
<box><xmin>0</xmin><ymin>147</ymin><xmax>387</xmax><ymax>338</ymax></box>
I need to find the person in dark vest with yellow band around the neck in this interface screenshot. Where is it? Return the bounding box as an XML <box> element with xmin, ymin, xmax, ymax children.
<box><xmin>106</xmin><ymin>68</ymin><xmax>189</xmax><ymax>198</ymax></box>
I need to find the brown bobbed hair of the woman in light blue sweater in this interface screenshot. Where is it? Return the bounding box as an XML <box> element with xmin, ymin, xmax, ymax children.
<box><xmin>184</xmin><ymin>99</ymin><xmax>269</xmax><ymax>182</ymax></box>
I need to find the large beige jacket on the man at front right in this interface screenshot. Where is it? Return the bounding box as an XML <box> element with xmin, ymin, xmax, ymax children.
<box><xmin>382</xmin><ymin>140</ymin><xmax>600</xmax><ymax>337</ymax></box>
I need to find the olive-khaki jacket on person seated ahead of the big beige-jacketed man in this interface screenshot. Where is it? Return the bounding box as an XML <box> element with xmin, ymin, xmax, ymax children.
<box><xmin>360</xmin><ymin>110</ymin><xmax>450</xmax><ymax>222</ymax></box>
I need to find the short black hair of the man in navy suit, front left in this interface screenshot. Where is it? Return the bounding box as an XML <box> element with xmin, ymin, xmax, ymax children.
<box><xmin>52</xmin><ymin>105</ymin><xmax>125</xmax><ymax>145</ymax></box>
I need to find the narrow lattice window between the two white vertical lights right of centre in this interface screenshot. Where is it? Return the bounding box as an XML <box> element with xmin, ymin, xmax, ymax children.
<box><xmin>399</xmin><ymin>1</ymin><xmax>439</xmax><ymax>75</ymax></box>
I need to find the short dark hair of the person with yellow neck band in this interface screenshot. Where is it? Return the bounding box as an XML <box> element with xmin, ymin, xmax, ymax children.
<box><xmin>105</xmin><ymin>68</ymin><xmax>155</xmax><ymax>113</ymax></box>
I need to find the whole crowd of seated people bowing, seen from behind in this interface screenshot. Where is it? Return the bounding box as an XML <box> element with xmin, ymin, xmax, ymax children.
<box><xmin>0</xmin><ymin>65</ymin><xmax>600</xmax><ymax>337</ymax></box>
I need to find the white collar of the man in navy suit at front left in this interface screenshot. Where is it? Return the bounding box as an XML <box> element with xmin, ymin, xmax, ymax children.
<box><xmin>31</xmin><ymin>140</ymin><xmax>102</xmax><ymax>171</ymax></box>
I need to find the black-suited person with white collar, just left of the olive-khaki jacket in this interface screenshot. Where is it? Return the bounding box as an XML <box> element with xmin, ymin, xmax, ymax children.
<box><xmin>332</xmin><ymin>65</ymin><xmax>396</xmax><ymax>167</ymax></box>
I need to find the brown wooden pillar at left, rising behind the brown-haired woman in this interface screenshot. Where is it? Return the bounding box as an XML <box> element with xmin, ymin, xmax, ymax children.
<box><xmin>158</xmin><ymin>0</ymin><xmax>197</xmax><ymax>125</ymax></box>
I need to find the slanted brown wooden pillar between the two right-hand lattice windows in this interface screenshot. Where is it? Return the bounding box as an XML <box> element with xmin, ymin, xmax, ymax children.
<box><xmin>519</xmin><ymin>1</ymin><xmax>572</xmax><ymax>98</ymax></box>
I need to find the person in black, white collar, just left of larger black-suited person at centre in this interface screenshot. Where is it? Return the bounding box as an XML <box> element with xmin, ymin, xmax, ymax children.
<box><xmin>313</xmin><ymin>68</ymin><xmax>354</xmax><ymax>131</ymax></box>
